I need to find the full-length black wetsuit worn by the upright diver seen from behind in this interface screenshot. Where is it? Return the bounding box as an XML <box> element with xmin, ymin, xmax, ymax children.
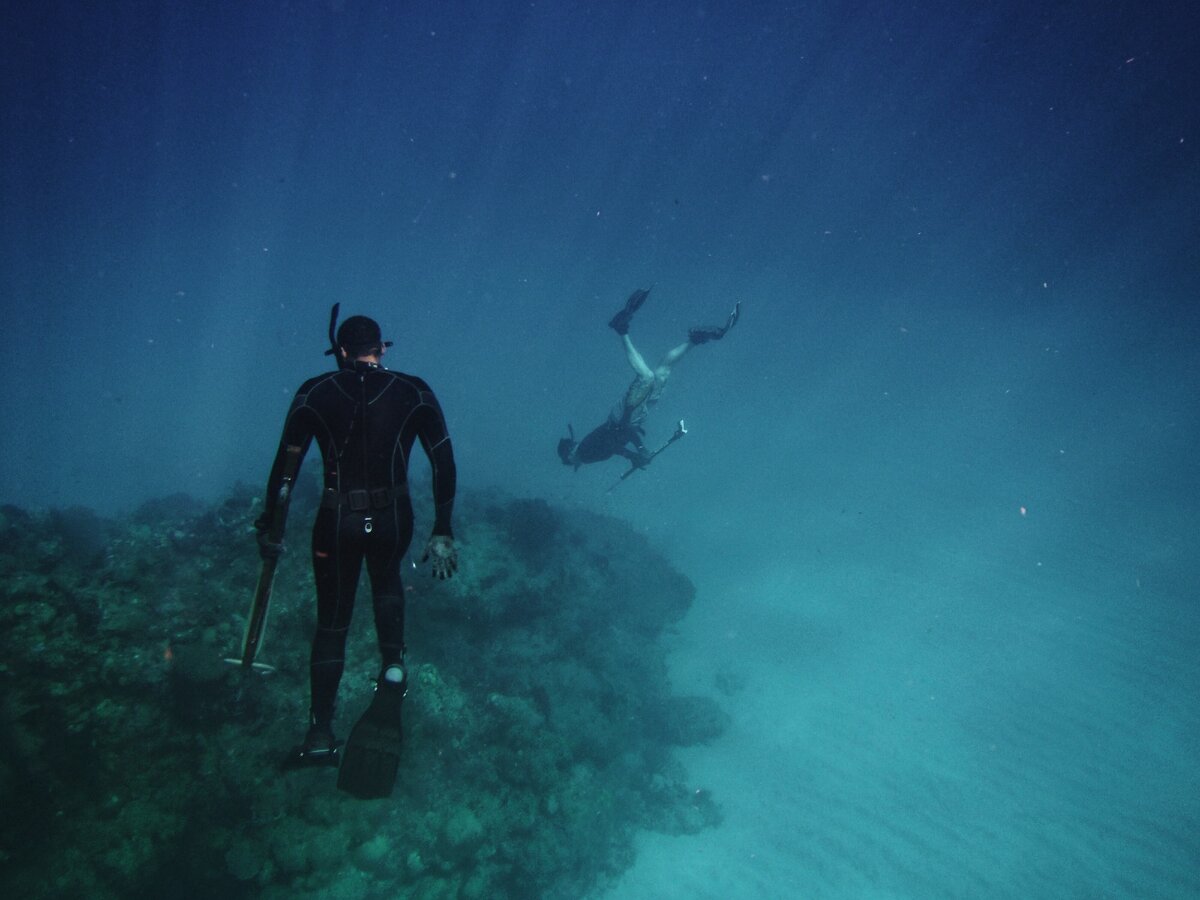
<box><xmin>260</xmin><ymin>361</ymin><xmax>456</xmax><ymax>726</ymax></box>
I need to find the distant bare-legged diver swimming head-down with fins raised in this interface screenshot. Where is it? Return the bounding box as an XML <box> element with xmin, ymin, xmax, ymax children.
<box><xmin>558</xmin><ymin>289</ymin><xmax>742</xmax><ymax>469</ymax></box>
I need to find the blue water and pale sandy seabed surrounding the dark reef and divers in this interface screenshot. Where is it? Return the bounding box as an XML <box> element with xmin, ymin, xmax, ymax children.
<box><xmin>0</xmin><ymin>0</ymin><xmax>1200</xmax><ymax>900</ymax></box>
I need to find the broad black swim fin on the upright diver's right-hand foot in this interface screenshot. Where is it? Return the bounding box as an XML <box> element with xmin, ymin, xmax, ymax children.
<box><xmin>337</xmin><ymin>678</ymin><xmax>408</xmax><ymax>800</ymax></box>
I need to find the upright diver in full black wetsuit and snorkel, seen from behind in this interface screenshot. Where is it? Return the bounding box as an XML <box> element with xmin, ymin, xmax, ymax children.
<box><xmin>254</xmin><ymin>305</ymin><xmax>457</xmax><ymax>797</ymax></box>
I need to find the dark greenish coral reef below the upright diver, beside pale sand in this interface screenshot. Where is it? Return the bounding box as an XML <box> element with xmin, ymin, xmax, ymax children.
<box><xmin>0</xmin><ymin>486</ymin><xmax>726</xmax><ymax>900</ymax></box>
